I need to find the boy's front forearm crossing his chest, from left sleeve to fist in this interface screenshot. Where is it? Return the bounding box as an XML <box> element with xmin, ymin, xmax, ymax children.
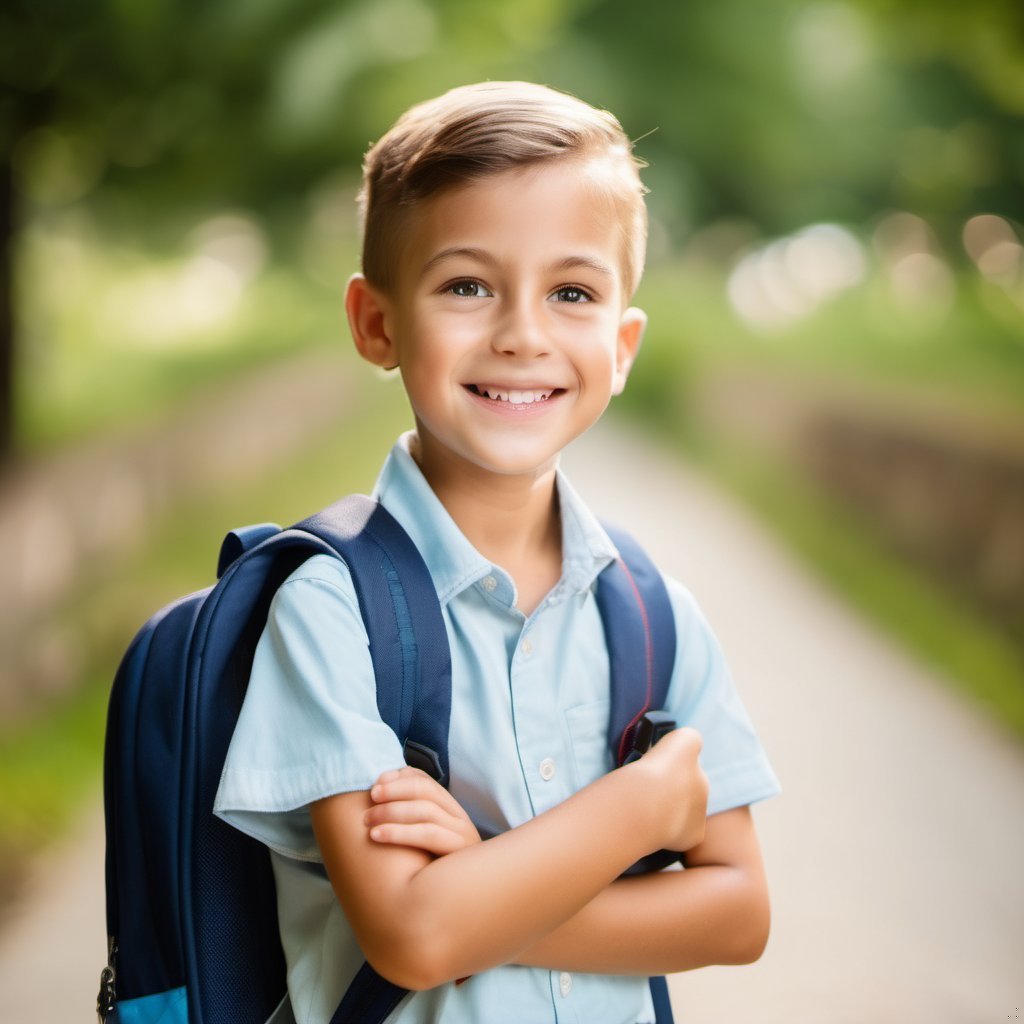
<box><xmin>311</xmin><ymin>729</ymin><xmax>707</xmax><ymax>989</ymax></box>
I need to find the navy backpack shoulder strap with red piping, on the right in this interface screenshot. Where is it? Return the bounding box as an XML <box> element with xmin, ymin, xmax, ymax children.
<box><xmin>597</xmin><ymin>523</ymin><xmax>676</xmax><ymax>764</ymax></box>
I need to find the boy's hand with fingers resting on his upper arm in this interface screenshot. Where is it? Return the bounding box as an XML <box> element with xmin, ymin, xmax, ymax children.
<box><xmin>364</xmin><ymin>767</ymin><xmax>480</xmax><ymax>857</ymax></box>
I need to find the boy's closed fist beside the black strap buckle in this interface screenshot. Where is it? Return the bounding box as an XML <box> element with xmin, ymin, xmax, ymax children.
<box><xmin>625</xmin><ymin>728</ymin><xmax>708</xmax><ymax>852</ymax></box>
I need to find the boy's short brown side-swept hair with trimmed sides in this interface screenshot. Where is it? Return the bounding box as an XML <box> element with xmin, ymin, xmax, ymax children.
<box><xmin>359</xmin><ymin>82</ymin><xmax>647</xmax><ymax>295</ymax></box>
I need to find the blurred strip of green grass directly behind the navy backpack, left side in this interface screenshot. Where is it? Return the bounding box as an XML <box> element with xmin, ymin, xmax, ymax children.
<box><xmin>0</xmin><ymin>384</ymin><xmax>408</xmax><ymax>874</ymax></box>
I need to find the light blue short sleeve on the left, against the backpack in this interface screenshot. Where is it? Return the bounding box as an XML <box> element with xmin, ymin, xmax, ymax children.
<box><xmin>214</xmin><ymin>555</ymin><xmax>404</xmax><ymax>861</ymax></box>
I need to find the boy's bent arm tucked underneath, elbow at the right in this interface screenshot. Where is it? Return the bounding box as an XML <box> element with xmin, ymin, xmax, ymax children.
<box><xmin>516</xmin><ymin>807</ymin><xmax>770</xmax><ymax>974</ymax></box>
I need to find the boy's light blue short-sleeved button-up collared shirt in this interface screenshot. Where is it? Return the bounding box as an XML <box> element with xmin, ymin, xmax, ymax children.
<box><xmin>215</xmin><ymin>435</ymin><xmax>778</xmax><ymax>1024</ymax></box>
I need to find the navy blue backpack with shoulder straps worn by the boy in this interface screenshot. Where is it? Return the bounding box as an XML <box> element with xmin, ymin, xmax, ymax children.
<box><xmin>97</xmin><ymin>495</ymin><xmax>678</xmax><ymax>1024</ymax></box>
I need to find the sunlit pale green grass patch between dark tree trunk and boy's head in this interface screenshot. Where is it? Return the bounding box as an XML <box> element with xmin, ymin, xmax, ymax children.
<box><xmin>15</xmin><ymin>211</ymin><xmax>355</xmax><ymax>455</ymax></box>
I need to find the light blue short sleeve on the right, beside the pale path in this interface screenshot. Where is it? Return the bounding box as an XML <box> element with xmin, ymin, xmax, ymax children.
<box><xmin>666</xmin><ymin>579</ymin><xmax>779</xmax><ymax>814</ymax></box>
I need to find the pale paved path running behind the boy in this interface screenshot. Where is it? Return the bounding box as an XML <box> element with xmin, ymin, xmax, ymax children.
<box><xmin>0</xmin><ymin>419</ymin><xmax>1024</xmax><ymax>1024</ymax></box>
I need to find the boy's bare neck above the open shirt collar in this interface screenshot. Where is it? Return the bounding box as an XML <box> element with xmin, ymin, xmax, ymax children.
<box><xmin>411</xmin><ymin>436</ymin><xmax>562</xmax><ymax>614</ymax></box>
